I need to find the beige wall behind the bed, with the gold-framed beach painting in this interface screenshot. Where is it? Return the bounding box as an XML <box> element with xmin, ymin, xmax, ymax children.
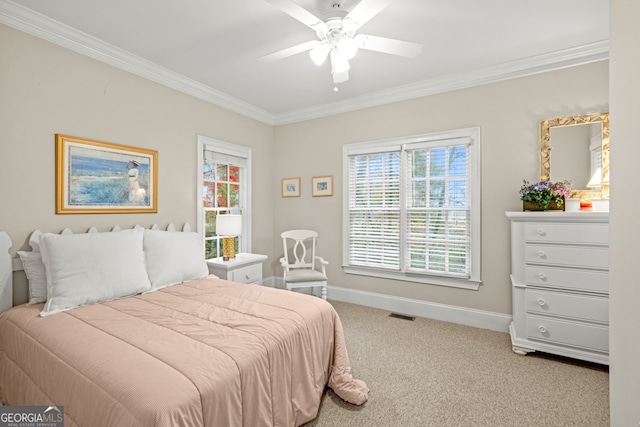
<box><xmin>0</xmin><ymin>25</ymin><xmax>274</xmax><ymax>272</ymax></box>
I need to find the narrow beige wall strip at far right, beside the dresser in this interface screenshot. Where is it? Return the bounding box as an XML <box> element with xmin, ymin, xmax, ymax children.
<box><xmin>609</xmin><ymin>0</ymin><xmax>640</xmax><ymax>427</ymax></box>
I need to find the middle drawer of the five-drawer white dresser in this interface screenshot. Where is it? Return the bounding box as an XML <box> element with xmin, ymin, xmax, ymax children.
<box><xmin>525</xmin><ymin>265</ymin><xmax>609</xmax><ymax>294</ymax></box>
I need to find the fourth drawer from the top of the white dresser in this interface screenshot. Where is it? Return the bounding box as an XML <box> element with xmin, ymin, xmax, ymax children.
<box><xmin>525</xmin><ymin>288</ymin><xmax>609</xmax><ymax>325</ymax></box>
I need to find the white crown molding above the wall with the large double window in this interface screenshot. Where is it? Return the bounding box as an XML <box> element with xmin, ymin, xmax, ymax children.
<box><xmin>275</xmin><ymin>40</ymin><xmax>609</xmax><ymax>125</ymax></box>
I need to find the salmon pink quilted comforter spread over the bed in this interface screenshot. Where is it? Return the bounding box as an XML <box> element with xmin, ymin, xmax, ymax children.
<box><xmin>0</xmin><ymin>276</ymin><xmax>368</xmax><ymax>427</ymax></box>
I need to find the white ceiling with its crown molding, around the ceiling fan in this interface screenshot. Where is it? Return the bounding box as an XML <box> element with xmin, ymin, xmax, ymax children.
<box><xmin>0</xmin><ymin>0</ymin><xmax>609</xmax><ymax>124</ymax></box>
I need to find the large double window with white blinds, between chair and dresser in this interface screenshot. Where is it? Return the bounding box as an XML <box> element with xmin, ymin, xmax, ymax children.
<box><xmin>344</xmin><ymin>128</ymin><xmax>480</xmax><ymax>289</ymax></box>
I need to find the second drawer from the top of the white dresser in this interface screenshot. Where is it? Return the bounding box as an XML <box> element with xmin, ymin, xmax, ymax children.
<box><xmin>524</xmin><ymin>245</ymin><xmax>609</xmax><ymax>270</ymax></box>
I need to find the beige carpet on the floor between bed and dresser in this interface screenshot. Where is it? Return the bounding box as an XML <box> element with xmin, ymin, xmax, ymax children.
<box><xmin>305</xmin><ymin>301</ymin><xmax>609</xmax><ymax>427</ymax></box>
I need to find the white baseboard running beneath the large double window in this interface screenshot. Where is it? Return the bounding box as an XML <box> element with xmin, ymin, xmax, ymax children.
<box><xmin>262</xmin><ymin>277</ymin><xmax>512</xmax><ymax>333</ymax></box>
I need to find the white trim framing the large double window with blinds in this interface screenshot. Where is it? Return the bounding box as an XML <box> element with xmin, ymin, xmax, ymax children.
<box><xmin>342</xmin><ymin>127</ymin><xmax>482</xmax><ymax>290</ymax></box>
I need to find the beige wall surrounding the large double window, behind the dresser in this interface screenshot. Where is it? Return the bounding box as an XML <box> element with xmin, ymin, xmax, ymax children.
<box><xmin>273</xmin><ymin>62</ymin><xmax>609</xmax><ymax>314</ymax></box>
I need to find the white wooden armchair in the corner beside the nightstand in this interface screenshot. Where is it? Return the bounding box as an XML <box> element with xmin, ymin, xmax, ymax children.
<box><xmin>280</xmin><ymin>230</ymin><xmax>329</xmax><ymax>300</ymax></box>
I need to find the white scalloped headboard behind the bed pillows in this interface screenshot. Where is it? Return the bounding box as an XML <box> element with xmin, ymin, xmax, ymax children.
<box><xmin>0</xmin><ymin>223</ymin><xmax>191</xmax><ymax>313</ymax></box>
